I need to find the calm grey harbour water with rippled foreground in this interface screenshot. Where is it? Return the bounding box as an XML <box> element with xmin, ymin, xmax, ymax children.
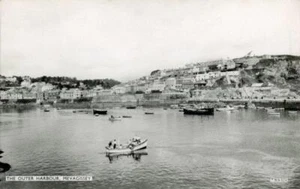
<box><xmin>0</xmin><ymin>108</ymin><xmax>300</xmax><ymax>189</ymax></box>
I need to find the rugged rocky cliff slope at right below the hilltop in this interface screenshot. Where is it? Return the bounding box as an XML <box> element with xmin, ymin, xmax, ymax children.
<box><xmin>214</xmin><ymin>56</ymin><xmax>300</xmax><ymax>95</ymax></box>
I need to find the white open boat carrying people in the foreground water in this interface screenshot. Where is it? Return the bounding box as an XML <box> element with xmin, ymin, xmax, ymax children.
<box><xmin>105</xmin><ymin>137</ymin><xmax>148</xmax><ymax>154</ymax></box>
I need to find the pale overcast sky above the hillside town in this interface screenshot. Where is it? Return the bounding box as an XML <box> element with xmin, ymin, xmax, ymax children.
<box><xmin>0</xmin><ymin>0</ymin><xmax>300</xmax><ymax>82</ymax></box>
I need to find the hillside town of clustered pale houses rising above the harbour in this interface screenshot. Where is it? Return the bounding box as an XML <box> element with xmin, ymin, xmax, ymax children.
<box><xmin>0</xmin><ymin>52</ymin><xmax>300</xmax><ymax>107</ymax></box>
